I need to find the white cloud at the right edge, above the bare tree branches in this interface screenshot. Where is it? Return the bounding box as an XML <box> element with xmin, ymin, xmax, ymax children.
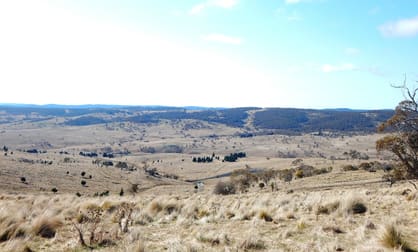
<box><xmin>378</xmin><ymin>16</ymin><xmax>418</xmax><ymax>37</ymax></box>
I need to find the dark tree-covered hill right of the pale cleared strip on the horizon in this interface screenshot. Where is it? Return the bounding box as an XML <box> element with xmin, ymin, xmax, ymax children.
<box><xmin>254</xmin><ymin>108</ymin><xmax>394</xmax><ymax>132</ymax></box>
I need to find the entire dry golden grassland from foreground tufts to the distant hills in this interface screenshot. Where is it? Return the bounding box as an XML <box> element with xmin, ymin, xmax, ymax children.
<box><xmin>0</xmin><ymin>117</ymin><xmax>418</xmax><ymax>252</ymax></box>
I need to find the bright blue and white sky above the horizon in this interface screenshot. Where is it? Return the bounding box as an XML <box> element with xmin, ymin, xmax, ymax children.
<box><xmin>0</xmin><ymin>0</ymin><xmax>418</xmax><ymax>109</ymax></box>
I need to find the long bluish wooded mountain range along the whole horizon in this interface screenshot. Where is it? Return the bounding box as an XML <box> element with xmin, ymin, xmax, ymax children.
<box><xmin>0</xmin><ymin>104</ymin><xmax>394</xmax><ymax>134</ymax></box>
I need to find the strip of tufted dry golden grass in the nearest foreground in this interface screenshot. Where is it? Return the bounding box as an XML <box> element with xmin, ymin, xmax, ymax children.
<box><xmin>0</xmin><ymin>178</ymin><xmax>418</xmax><ymax>251</ymax></box>
